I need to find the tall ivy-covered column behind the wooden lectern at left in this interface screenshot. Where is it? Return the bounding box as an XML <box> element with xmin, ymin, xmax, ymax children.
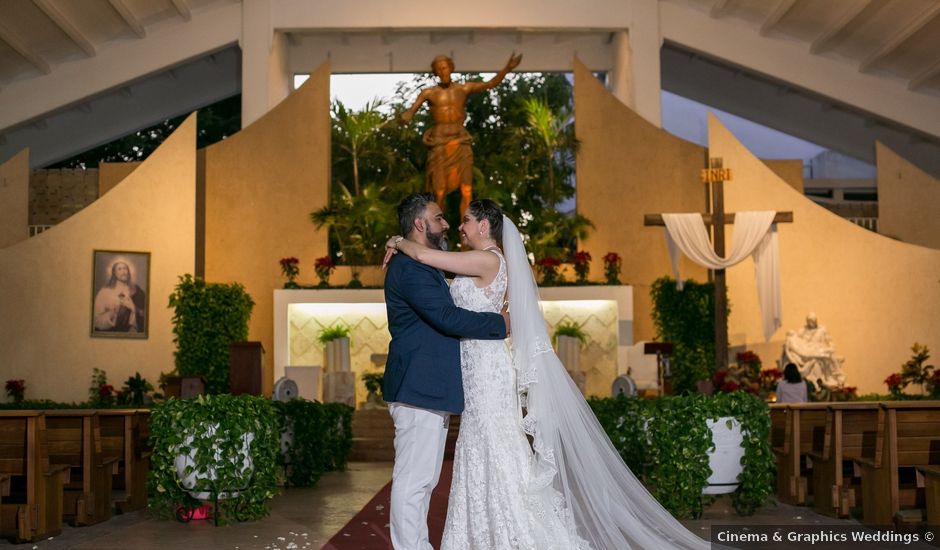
<box><xmin>169</xmin><ymin>273</ymin><xmax>255</xmax><ymax>394</ymax></box>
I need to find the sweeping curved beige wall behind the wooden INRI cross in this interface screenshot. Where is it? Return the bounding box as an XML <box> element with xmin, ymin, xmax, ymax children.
<box><xmin>709</xmin><ymin>116</ymin><xmax>940</xmax><ymax>393</ymax></box>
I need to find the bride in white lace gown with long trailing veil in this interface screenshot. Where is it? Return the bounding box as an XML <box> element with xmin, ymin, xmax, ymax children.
<box><xmin>387</xmin><ymin>199</ymin><xmax>709</xmax><ymax>550</ymax></box>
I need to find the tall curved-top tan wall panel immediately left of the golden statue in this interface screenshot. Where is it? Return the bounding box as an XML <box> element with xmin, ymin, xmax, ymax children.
<box><xmin>205</xmin><ymin>61</ymin><xmax>337</xmax><ymax>393</ymax></box>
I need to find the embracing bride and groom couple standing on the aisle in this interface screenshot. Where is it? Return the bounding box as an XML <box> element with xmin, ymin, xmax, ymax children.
<box><xmin>383</xmin><ymin>193</ymin><xmax>709</xmax><ymax>550</ymax></box>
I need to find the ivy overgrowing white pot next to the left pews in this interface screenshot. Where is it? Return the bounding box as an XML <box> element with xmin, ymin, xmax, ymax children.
<box><xmin>147</xmin><ymin>395</ymin><xmax>280</xmax><ymax>524</ymax></box>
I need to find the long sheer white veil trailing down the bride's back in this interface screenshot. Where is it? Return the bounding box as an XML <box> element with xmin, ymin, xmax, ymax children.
<box><xmin>503</xmin><ymin>217</ymin><xmax>709</xmax><ymax>550</ymax></box>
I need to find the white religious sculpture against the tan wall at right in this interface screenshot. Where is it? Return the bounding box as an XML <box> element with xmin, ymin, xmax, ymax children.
<box><xmin>782</xmin><ymin>313</ymin><xmax>845</xmax><ymax>387</ymax></box>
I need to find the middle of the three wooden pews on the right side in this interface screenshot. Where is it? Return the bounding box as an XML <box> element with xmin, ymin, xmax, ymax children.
<box><xmin>809</xmin><ymin>401</ymin><xmax>884</xmax><ymax>517</ymax></box>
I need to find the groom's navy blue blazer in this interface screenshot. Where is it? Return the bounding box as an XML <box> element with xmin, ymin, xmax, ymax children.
<box><xmin>382</xmin><ymin>254</ymin><xmax>506</xmax><ymax>414</ymax></box>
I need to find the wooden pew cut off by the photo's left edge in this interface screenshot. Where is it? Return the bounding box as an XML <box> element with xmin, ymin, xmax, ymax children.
<box><xmin>0</xmin><ymin>411</ymin><xmax>67</xmax><ymax>542</ymax></box>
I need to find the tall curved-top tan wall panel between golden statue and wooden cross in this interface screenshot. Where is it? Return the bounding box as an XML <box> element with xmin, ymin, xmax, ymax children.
<box><xmin>574</xmin><ymin>61</ymin><xmax>707</xmax><ymax>341</ymax></box>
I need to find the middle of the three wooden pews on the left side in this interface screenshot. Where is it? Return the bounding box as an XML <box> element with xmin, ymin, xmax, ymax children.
<box><xmin>46</xmin><ymin>409</ymin><xmax>117</xmax><ymax>525</ymax></box>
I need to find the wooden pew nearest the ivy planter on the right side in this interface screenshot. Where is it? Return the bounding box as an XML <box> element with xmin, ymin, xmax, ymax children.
<box><xmin>771</xmin><ymin>403</ymin><xmax>829</xmax><ymax>504</ymax></box>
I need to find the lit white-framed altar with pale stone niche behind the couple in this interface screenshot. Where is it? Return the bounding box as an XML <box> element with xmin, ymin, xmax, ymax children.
<box><xmin>274</xmin><ymin>285</ymin><xmax>633</xmax><ymax>403</ymax></box>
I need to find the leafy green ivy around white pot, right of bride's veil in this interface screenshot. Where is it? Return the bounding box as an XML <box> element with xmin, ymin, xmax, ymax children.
<box><xmin>590</xmin><ymin>392</ymin><xmax>776</xmax><ymax>518</ymax></box>
